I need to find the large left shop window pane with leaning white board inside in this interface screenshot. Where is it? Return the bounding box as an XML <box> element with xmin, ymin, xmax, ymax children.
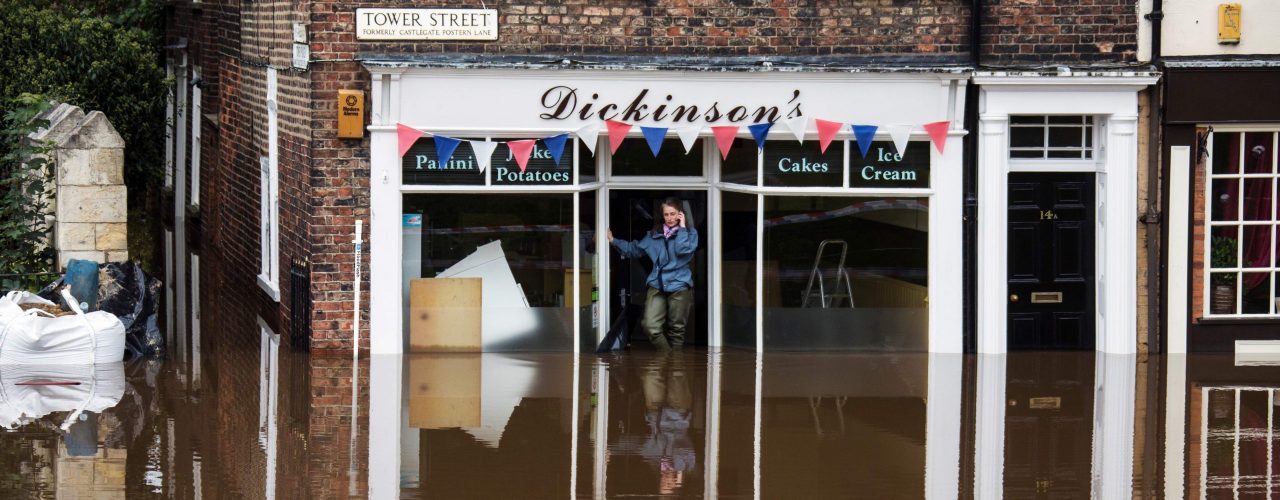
<box><xmin>403</xmin><ymin>193</ymin><xmax>576</xmax><ymax>350</ymax></box>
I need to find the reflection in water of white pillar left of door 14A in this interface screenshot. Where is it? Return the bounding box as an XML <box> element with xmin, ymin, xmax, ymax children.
<box><xmin>972</xmin><ymin>354</ymin><xmax>1006</xmax><ymax>500</ymax></box>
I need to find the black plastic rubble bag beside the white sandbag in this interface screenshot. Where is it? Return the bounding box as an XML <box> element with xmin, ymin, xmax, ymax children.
<box><xmin>97</xmin><ymin>262</ymin><xmax>165</xmax><ymax>359</ymax></box>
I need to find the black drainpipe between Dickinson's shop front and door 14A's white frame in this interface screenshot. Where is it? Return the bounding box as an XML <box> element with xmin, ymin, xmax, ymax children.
<box><xmin>964</xmin><ymin>0</ymin><xmax>983</xmax><ymax>353</ymax></box>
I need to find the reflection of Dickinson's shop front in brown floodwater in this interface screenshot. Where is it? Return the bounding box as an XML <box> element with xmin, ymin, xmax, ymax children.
<box><xmin>384</xmin><ymin>352</ymin><xmax>961</xmax><ymax>499</ymax></box>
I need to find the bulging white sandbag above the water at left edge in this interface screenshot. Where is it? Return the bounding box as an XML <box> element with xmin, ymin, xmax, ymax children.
<box><xmin>0</xmin><ymin>292</ymin><xmax>124</xmax><ymax>364</ymax></box>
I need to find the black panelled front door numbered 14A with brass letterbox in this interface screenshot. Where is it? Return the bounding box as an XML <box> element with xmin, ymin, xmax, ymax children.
<box><xmin>1007</xmin><ymin>173</ymin><xmax>1096</xmax><ymax>350</ymax></box>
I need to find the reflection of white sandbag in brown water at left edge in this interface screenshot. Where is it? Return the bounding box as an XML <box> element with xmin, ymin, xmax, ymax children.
<box><xmin>0</xmin><ymin>361</ymin><xmax>124</xmax><ymax>428</ymax></box>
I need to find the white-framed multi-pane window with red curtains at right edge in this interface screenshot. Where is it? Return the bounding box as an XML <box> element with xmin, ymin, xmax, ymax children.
<box><xmin>1204</xmin><ymin>132</ymin><xmax>1280</xmax><ymax>316</ymax></box>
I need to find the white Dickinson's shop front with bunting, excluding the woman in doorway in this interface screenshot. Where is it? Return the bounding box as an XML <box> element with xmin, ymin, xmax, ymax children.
<box><xmin>365</xmin><ymin>61</ymin><xmax>966</xmax><ymax>353</ymax></box>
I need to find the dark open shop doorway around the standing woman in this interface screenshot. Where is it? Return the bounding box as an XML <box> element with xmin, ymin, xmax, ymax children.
<box><xmin>602</xmin><ymin>189</ymin><xmax>710</xmax><ymax>348</ymax></box>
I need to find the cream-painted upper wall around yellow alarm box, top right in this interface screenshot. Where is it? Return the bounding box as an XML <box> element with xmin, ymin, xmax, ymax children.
<box><xmin>1162</xmin><ymin>0</ymin><xmax>1280</xmax><ymax>56</ymax></box>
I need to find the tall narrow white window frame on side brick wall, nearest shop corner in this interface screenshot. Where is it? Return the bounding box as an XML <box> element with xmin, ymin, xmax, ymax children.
<box><xmin>257</xmin><ymin>68</ymin><xmax>280</xmax><ymax>302</ymax></box>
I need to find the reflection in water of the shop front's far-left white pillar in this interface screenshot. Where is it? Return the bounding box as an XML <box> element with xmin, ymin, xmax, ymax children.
<box><xmin>369</xmin><ymin>355</ymin><xmax>404</xmax><ymax>499</ymax></box>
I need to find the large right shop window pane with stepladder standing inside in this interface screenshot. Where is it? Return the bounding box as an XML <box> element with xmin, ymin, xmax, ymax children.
<box><xmin>762</xmin><ymin>196</ymin><xmax>929</xmax><ymax>350</ymax></box>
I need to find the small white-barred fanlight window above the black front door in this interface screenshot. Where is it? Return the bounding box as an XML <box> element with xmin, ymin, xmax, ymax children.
<box><xmin>1009</xmin><ymin>115</ymin><xmax>1094</xmax><ymax>160</ymax></box>
